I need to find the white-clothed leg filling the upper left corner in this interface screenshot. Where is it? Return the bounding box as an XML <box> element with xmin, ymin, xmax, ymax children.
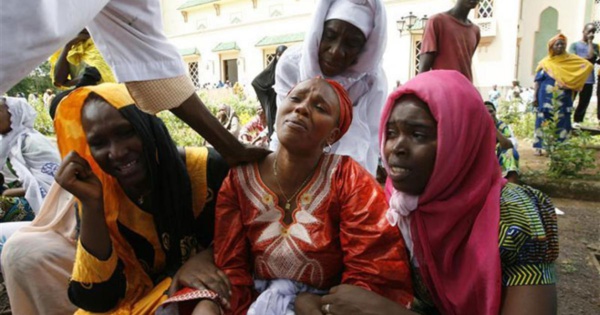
<box><xmin>0</xmin><ymin>0</ymin><xmax>110</xmax><ymax>95</ymax></box>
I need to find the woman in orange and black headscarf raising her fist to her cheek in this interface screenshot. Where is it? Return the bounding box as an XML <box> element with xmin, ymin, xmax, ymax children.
<box><xmin>55</xmin><ymin>83</ymin><xmax>228</xmax><ymax>314</ymax></box>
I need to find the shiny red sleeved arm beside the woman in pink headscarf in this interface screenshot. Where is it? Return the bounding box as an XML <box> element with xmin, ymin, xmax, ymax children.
<box><xmin>339</xmin><ymin>159</ymin><xmax>413</xmax><ymax>305</ymax></box>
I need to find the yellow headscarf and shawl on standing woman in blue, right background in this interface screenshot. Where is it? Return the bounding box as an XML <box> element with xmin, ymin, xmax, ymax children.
<box><xmin>535</xmin><ymin>34</ymin><xmax>594</xmax><ymax>91</ymax></box>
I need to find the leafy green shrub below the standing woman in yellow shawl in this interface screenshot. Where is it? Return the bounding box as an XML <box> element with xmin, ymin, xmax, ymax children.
<box><xmin>541</xmin><ymin>89</ymin><xmax>595</xmax><ymax>177</ymax></box>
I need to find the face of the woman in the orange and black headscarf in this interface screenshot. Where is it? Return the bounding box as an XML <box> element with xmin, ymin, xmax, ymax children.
<box><xmin>81</xmin><ymin>100</ymin><xmax>149</xmax><ymax>189</ymax></box>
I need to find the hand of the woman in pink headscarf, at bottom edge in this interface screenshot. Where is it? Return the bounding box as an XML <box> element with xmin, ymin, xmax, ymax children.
<box><xmin>321</xmin><ymin>284</ymin><xmax>414</xmax><ymax>315</ymax></box>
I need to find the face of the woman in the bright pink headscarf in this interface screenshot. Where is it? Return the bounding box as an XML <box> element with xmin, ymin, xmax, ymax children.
<box><xmin>383</xmin><ymin>95</ymin><xmax>437</xmax><ymax>195</ymax></box>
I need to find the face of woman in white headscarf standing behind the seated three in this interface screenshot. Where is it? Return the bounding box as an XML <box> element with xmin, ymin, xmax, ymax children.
<box><xmin>319</xmin><ymin>20</ymin><xmax>367</xmax><ymax>77</ymax></box>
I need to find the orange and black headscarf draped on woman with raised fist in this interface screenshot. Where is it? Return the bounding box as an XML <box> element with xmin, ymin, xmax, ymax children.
<box><xmin>54</xmin><ymin>83</ymin><xmax>208</xmax><ymax>314</ymax></box>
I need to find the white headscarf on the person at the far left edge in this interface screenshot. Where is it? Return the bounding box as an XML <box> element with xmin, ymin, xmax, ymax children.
<box><xmin>0</xmin><ymin>97</ymin><xmax>60</xmax><ymax>214</ymax></box>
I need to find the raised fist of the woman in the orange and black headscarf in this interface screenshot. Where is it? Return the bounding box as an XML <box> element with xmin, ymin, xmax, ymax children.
<box><xmin>54</xmin><ymin>151</ymin><xmax>102</xmax><ymax>208</ymax></box>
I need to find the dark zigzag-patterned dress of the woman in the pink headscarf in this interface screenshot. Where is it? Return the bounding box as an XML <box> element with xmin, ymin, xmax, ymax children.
<box><xmin>411</xmin><ymin>183</ymin><xmax>558</xmax><ymax>314</ymax></box>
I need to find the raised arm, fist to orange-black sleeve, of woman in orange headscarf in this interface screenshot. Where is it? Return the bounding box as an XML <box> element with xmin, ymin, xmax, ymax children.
<box><xmin>56</xmin><ymin>151</ymin><xmax>126</xmax><ymax>312</ymax></box>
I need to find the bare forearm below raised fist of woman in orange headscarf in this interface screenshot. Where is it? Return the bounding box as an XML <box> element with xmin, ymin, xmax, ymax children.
<box><xmin>80</xmin><ymin>202</ymin><xmax>112</xmax><ymax>260</ymax></box>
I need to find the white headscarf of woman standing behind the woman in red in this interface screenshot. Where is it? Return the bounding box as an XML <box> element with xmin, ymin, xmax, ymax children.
<box><xmin>274</xmin><ymin>0</ymin><xmax>387</xmax><ymax>174</ymax></box>
